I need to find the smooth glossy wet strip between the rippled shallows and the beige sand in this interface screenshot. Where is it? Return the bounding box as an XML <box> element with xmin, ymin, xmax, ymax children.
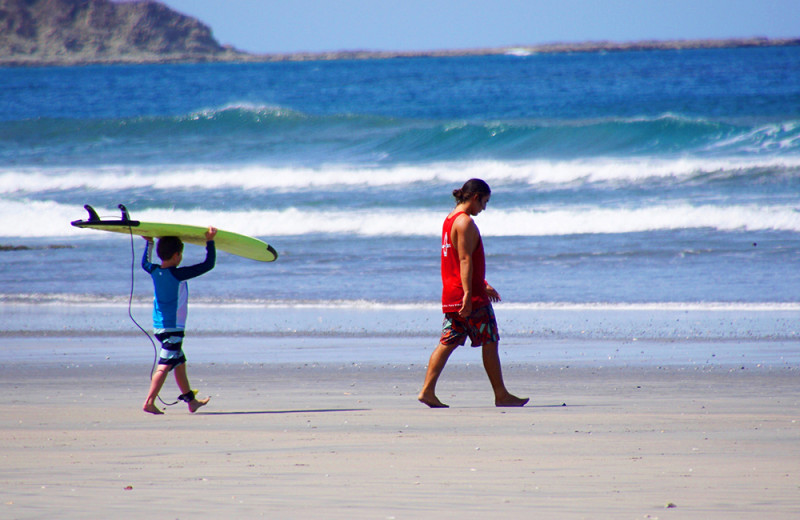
<box><xmin>0</xmin><ymin>333</ymin><xmax>800</xmax><ymax>372</ymax></box>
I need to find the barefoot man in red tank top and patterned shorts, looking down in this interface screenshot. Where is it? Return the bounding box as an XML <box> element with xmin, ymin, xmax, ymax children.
<box><xmin>418</xmin><ymin>179</ymin><xmax>528</xmax><ymax>408</ymax></box>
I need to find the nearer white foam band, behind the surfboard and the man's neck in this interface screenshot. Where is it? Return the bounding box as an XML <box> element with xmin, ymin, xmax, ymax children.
<box><xmin>0</xmin><ymin>198</ymin><xmax>800</xmax><ymax>237</ymax></box>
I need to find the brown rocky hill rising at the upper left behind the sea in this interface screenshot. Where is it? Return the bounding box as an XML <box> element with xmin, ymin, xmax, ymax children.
<box><xmin>0</xmin><ymin>0</ymin><xmax>243</xmax><ymax>65</ymax></box>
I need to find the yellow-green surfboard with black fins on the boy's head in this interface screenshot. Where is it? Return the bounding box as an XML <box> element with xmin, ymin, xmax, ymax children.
<box><xmin>70</xmin><ymin>204</ymin><xmax>278</xmax><ymax>262</ymax></box>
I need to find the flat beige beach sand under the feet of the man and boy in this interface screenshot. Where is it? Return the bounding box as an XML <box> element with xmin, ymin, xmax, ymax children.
<box><xmin>0</xmin><ymin>338</ymin><xmax>800</xmax><ymax>520</ymax></box>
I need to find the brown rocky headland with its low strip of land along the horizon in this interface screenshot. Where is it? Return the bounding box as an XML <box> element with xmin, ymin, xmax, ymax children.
<box><xmin>0</xmin><ymin>0</ymin><xmax>800</xmax><ymax>67</ymax></box>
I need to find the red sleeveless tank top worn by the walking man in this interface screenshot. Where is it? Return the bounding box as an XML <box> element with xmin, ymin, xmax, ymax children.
<box><xmin>442</xmin><ymin>211</ymin><xmax>489</xmax><ymax>312</ymax></box>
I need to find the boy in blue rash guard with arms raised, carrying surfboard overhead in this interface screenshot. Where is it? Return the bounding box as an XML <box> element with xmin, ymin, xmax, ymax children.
<box><xmin>142</xmin><ymin>227</ymin><xmax>217</xmax><ymax>414</ymax></box>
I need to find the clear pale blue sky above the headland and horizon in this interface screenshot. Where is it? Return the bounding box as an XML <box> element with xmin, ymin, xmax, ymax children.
<box><xmin>162</xmin><ymin>0</ymin><xmax>800</xmax><ymax>53</ymax></box>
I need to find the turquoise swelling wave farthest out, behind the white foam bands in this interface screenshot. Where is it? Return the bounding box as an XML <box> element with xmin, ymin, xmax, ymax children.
<box><xmin>6</xmin><ymin>109</ymin><xmax>800</xmax><ymax>164</ymax></box>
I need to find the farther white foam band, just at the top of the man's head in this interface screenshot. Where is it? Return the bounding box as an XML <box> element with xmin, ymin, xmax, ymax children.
<box><xmin>0</xmin><ymin>156</ymin><xmax>800</xmax><ymax>194</ymax></box>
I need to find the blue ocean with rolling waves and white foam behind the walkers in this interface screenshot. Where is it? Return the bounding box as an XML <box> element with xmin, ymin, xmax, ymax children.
<box><xmin>0</xmin><ymin>47</ymin><xmax>800</xmax><ymax>341</ymax></box>
